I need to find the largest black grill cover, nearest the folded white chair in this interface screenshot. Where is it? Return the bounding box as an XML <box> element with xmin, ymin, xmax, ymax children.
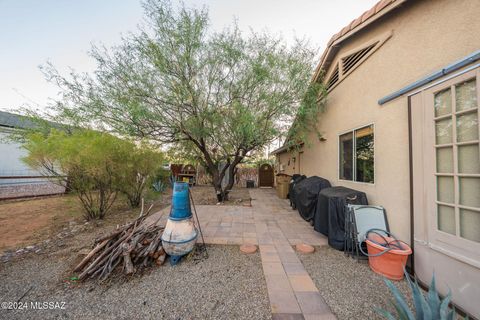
<box><xmin>313</xmin><ymin>187</ymin><xmax>368</xmax><ymax>250</ymax></box>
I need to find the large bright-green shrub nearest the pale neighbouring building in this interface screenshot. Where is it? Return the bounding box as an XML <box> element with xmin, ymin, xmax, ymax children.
<box><xmin>24</xmin><ymin>130</ymin><xmax>119</xmax><ymax>220</ymax></box>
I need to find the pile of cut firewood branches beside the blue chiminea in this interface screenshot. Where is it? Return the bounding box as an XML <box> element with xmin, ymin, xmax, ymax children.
<box><xmin>74</xmin><ymin>205</ymin><xmax>167</xmax><ymax>280</ymax></box>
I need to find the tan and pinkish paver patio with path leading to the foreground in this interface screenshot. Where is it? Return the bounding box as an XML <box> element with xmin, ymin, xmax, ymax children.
<box><xmin>149</xmin><ymin>189</ymin><xmax>335</xmax><ymax>320</ymax></box>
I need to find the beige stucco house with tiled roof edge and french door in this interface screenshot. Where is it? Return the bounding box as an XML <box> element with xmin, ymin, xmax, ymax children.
<box><xmin>272</xmin><ymin>0</ymin><xmax>480</xmax><ymax>318</ymax></box>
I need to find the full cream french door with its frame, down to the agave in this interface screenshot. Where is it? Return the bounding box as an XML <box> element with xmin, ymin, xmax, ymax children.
<box><xmin>410</xmin><ymin>67</ymin><xmax>480</xmax><ymax>315</ymax></box>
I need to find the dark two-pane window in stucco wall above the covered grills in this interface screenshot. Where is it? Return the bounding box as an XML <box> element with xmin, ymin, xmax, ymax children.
<box><xmin>338</xmin><ymin>124</ymin><xmax>375</xmax><ymax>184</ymax></box>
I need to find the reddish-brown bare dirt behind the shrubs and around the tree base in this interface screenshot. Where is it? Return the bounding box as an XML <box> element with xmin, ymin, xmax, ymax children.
<box><xmin>0</xmin><ymin>186</ymin><xmax>250</xmax><ymax>255</ymax></box>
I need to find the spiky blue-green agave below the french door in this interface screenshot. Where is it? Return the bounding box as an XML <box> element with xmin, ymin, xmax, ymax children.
<box><xmin>378</xmin><ymin>272</ymin><xmax>455</xmax><ymax>320</ymax></box>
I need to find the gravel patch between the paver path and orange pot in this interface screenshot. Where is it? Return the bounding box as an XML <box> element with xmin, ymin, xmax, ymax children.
<box><xmin>299</xmin><ymin>246</ymin><xmax>411</xmax><ymax>320</ymax></box>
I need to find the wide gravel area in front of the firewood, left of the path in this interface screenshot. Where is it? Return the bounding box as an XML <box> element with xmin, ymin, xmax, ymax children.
<box><xmin>0</xmin><ymin>246</ymin><xmax>271</xmax><ymax>319</ymax></box>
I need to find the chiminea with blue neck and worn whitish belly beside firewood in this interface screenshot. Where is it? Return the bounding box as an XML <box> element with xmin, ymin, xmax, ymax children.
<box><xmin>162</xmin><ymin>182</ymin><xmax>198</xmax><ymax>265</ymax></box>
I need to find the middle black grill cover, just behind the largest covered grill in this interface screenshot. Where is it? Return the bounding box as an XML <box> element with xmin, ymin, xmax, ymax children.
<box><xmin>293</xmin><ymin>176</ymin><xmax>331</xmax><ymax>221</ymax></box>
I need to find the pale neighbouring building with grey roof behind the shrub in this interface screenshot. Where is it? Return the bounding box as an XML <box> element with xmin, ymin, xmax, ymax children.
<box><xmin>0</xmin><ymin>111</ymin><xmax>65</xmax><ymax>200</ymax></box>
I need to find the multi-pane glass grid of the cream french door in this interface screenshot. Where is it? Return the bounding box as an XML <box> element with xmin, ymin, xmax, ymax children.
<box><xmin>433</xmin><ymin>75</ymin><xmax>480</xmax><ymax>243</ymax></box>
